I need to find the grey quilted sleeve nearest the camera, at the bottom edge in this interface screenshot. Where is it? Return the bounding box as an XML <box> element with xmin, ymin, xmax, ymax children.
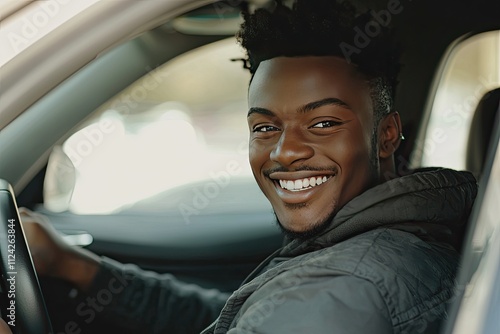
<box><xmin>228</xmin><ymin>276</ymin><xmax>393</xmax><ymax>334</ymax></box>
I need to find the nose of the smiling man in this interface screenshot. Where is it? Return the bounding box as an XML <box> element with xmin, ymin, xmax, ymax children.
<box><xmin>270</xmin><ymin>129</ymin><xmax>314</xmax><ymax>166</ymax></box>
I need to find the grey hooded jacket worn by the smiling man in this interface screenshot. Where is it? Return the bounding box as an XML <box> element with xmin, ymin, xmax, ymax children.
<box><xmin>86</xmin><ymin>169</ymin><xmax>477</xmax><ymax>334</ymax></box>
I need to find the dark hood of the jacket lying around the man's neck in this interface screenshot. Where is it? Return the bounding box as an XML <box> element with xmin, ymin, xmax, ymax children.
<box><xmin>280</xmin><ymin>168</ymin><xmax>477</xmax><ymax>257</ymax></box>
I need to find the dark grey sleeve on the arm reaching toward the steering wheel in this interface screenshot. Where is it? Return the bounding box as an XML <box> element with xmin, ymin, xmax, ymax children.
<box><xmin>83</xmin><ymin>257</ymin><xmax>229</xmax><ymax>334</ymax></box>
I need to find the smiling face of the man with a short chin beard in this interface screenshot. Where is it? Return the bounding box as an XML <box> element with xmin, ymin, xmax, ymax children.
<box><xmin>248</xmin><ymin>57</ymin><xmax>378</xmax><ymax>235</ymax></box>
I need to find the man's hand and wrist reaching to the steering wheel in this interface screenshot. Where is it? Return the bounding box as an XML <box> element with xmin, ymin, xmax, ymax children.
<box><xmin>19</xmin><ymin>208</ymin><xmax>100</xmax><ymax>290</ymax></box>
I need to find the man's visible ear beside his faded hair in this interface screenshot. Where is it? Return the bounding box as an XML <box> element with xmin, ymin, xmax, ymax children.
<box><xmin>378</xmin><ymin>112</ymin><xmax>403</xmax><ymax>159</ymax></box>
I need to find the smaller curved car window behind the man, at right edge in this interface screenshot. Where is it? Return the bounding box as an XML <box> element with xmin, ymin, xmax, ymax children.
<box><xmin>414</xmin><ymin>31</ymin><xmax>500</xmax><ymax>170</ymax></box>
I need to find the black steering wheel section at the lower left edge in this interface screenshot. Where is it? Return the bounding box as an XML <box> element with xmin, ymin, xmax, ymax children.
<box><xmin>0</xmin><ymin>179</ymin><xmax>53</xmax><ymax>334</ymax></box>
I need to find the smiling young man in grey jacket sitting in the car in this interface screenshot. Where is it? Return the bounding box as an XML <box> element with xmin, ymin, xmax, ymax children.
<box><xmin>17</xmin><ymin>0</ymin><xmax>476</xmax><ymax>333</ymax></box>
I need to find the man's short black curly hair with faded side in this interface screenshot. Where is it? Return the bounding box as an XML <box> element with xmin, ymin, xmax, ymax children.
<box><xmin>236</xmin><ymin>0</ymin><xmax>400</xmax><ymax>128</ymax></box>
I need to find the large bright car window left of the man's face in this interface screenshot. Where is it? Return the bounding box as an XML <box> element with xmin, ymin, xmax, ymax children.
<box><xmin>44</xmin><ymin>38</ymin><xmax>251</xmax><ymax>214</ymax></box>
